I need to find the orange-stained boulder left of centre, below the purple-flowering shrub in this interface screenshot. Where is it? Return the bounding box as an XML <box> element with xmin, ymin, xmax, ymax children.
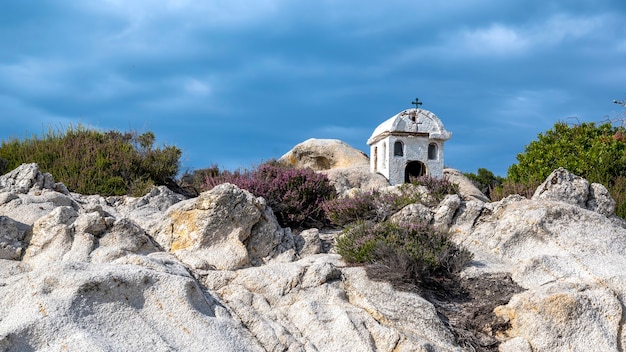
<box><xmin>153</xmin><ymin>183</ymin><xmax>295</xmax><ymax>270</ymax></box>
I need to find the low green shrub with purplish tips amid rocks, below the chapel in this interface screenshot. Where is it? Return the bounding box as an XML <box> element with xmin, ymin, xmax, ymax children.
<box><xmin>337</xmin><ymin>221</ymin><xmax>472</xmax><ymax>284</ymax></box>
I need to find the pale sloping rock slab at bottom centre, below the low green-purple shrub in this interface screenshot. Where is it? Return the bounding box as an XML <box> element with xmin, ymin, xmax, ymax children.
<box><xmin>202</xmin><ymin>255</ymin><xmax>460</xmax><ymax>351</ymax></box>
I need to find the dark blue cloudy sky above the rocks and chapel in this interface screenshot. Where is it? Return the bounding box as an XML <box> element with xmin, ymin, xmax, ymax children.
<box><xmin>0</xmin><ymin>0</ymin><xmax>626</xmax><ymax>175</ymax></box>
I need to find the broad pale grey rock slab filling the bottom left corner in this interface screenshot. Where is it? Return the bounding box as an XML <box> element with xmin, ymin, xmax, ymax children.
<box><xmin>0</xmin><ymin>257</ymin><xmax>263</xmax><ymax>351</ymax></box>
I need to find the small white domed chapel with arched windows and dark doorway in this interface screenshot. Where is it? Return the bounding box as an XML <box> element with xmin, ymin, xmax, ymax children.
<box><xmin>367</xmin><ymin>105</ymin><xmax>452</xmax><ymax>185</ymax></box>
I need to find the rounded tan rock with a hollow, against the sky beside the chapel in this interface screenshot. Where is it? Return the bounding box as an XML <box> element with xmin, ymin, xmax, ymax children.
<box><xmin>279</xmin><ymin>138</ymin><xmax>369</xmax><ymax>171</ymax></box>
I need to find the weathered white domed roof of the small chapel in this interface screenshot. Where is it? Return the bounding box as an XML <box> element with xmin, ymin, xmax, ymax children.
<box><xmin>367</xmin><ymin>109</ymin><xmax>452</xmax><ymax>145</ymax></box>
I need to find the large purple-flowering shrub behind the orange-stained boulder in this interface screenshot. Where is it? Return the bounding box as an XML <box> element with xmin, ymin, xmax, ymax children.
<box><xmin>203</xmin><ymin>162</ymin><xmax>336</xmax><ymax>228</ymax></box>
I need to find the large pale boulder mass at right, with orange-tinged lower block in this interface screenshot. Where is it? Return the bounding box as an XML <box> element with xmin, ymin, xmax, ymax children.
<box><xmin>451</xmin><ymin>169</ymin><xmax>626</xmax><ymax>351</ymax></box>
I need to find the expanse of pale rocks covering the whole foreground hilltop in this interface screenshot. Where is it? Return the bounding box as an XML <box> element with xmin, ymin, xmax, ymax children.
<box><xmin>0</xmin><ymin>142</ymin><xmax>626</xmax><ymax>351</ymax></box>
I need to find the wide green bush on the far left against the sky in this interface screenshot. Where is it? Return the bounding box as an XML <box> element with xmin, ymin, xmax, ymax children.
<box><xmin>0</xmin><ymin>126</ymin><xmax>182</xmax><ymax>196</ymax></box>
